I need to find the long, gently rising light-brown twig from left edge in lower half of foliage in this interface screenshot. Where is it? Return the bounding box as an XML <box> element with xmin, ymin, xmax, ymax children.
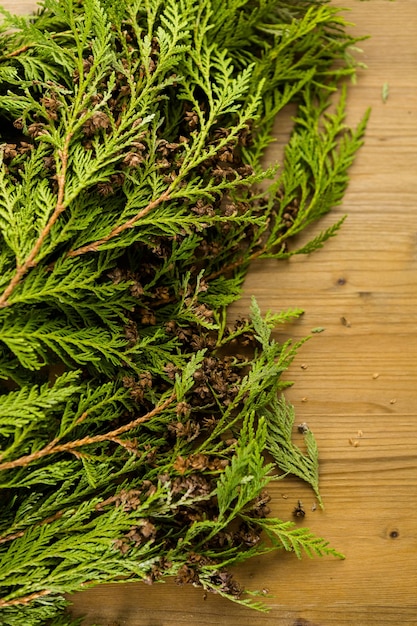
<box><xmin>0</xmin><ymin>393</ymin><xmax>176</xmax><ymax>471</ymax></box>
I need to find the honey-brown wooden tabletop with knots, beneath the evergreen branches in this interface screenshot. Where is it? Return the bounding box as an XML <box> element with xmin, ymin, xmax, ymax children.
<box><xmin>7</xmin><ymin>0</ymin><xmax>417</xmax><ymax>626</ymax></box>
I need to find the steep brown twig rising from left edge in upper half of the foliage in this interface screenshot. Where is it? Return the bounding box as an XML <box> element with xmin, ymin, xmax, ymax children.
<box><xmin>0</xmin><ymin>133</ymin><xmax>72</xmax><ymax>308</ymax></box>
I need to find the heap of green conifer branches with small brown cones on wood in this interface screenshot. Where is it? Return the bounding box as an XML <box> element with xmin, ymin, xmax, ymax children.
<box><xmin>0</xmin><ymin>0</ymin><xmax>366</xmax><ymax>626</ymax></box>
